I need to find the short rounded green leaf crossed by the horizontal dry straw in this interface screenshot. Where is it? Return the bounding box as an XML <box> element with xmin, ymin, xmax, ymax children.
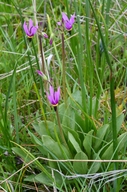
<box><xmin>73</xmin><ymin>151</ymin><xmax>88</xmax><ymax>174</ymax></box>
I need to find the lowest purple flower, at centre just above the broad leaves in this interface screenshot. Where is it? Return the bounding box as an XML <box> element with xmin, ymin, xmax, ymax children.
<box><xmin>47</xmin><ymin>85</ymin><xmax>60</xmax><ymax>107</ymax></box>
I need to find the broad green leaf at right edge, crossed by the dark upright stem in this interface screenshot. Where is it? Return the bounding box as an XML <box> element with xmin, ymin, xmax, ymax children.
<box><xmin>101</xmin><ymin>132</ymin><xmax>127</xmax><ymax>159</ymax></box>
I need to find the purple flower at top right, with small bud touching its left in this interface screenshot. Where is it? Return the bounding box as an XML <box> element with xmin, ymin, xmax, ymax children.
<box><xmin>57</xmin><ymin>12</ymin><xmax>75</xmax><ymax>31</ymax></box>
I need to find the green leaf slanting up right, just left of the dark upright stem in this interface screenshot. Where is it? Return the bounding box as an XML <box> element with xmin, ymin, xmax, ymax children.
<box><xmin>93</xmin><ymin>124</ymin><xmax>109</xmax><ymax>151</ymax></box>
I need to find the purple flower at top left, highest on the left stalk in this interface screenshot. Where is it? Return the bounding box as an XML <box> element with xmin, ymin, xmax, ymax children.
<box><xmin>23</xmin><ymin>19</ymin><xmax>38</xmax><ymax>38</ymax></box>
